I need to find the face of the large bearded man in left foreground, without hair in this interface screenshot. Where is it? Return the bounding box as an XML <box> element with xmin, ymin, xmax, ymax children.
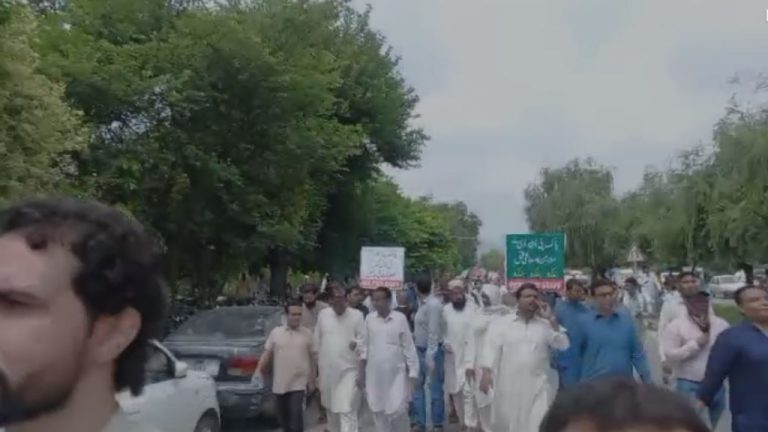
<box><xmin>0</xmin><ymin>233</ymin><xmax>89</xmax><ymax>427</ymax></box>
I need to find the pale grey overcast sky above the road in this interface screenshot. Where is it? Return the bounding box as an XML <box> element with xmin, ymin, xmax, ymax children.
<box><xmin>354</xmin><ymin>0</ymin><xmax>768</xmax><ymax>247</ymax></box>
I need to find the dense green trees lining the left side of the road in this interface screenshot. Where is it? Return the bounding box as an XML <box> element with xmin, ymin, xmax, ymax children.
<box><xmin>0</xmin><ymin>0</ymin><xmax>480</xmax><ymax>298</ymax></box>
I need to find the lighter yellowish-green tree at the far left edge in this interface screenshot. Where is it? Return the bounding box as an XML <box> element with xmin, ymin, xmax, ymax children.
<box><xmin>0</xmin><ymin>0</ymin><xmax>87</xmax><ymax>202</ymax></box>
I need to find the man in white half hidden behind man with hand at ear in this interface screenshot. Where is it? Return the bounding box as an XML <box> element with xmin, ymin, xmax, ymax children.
<box><xmin>464</xmin><ymin>284</ymin><xmax>510</xmax><ymax>432</ymax></box>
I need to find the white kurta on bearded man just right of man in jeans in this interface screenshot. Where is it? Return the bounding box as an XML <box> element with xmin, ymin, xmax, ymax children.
<box><xmin>443</xmin><ymin>298</ymin><xmax>477</xmax><ymax>394</ymax></box>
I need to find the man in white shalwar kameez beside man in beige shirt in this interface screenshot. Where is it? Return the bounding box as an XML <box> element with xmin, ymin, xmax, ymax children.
<box><xmin>315</xmin><ymin>286</ymin><xmax>366</xmax><ymax>432</ymax></box>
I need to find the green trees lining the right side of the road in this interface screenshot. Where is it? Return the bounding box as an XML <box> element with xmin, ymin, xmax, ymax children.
<box><xmin>525</xmin><ymin>93</ymin><xmax>768</xmax><ymax>281</ymax></box>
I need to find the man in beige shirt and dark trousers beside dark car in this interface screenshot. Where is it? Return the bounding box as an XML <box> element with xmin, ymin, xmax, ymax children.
<box><xmin>255</xmin><ymin>300</ymin><xmax>317</xmax><ymax>432</ymax></box>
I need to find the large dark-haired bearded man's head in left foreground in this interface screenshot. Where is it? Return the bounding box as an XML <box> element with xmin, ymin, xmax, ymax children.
<box><xmin>0</xmin><ymin>199</ymin><xmax>167</xmax><ymax>432</ymax></box>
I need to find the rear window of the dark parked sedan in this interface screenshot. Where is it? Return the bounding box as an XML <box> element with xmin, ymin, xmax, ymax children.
<box><xmin>172</xmin><ymin>307</ymin><xmax>276</xmax><ymax>339</ymax></box>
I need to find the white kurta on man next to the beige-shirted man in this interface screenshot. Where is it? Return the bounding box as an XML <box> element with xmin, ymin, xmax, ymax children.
<box><xmin>315</xmin><ymin>308</ymin><xmax>366</xmax><ymax>413</ymax></box>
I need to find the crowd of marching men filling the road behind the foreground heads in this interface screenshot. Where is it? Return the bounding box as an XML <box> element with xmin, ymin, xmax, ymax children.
<box><xmin>252</xmin><ymin>266</ymin><xmax>768</xmax><ymax>432</ymax></box>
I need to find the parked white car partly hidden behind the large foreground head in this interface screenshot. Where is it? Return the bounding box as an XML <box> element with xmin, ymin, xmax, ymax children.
<box><xmin>117</xmin><ymin>341</ymin><xmax>221</xmax><ymax>432</ymax></box>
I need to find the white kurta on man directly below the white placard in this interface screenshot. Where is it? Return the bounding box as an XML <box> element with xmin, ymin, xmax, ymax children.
<box><xmin>365</xmin><ymin>311</ymin><xmax>419</xmax><ymax>415</ymax></box>
